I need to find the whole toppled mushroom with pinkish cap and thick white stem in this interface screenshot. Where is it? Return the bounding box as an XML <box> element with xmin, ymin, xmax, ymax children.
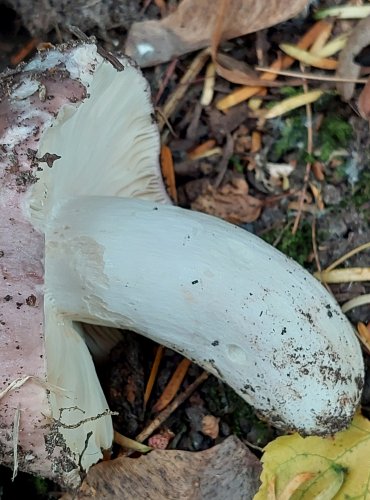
<box><xmin>0</xmin><ymin>43</ymin><xmax>364</xmax><ymax>486</ymax></box>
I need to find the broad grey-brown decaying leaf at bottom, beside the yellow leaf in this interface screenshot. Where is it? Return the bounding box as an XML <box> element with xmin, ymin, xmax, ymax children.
<box><xmin>62</xmin><ymin>436</ymin><xmax>261</xmax><ymax>500</ymax></box>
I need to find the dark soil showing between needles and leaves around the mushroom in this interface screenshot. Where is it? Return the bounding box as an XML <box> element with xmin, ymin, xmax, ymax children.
<box><xmin>0</xmin><ymin>3</ymin><xmax>370</xmax><ymax>500</ymax></box>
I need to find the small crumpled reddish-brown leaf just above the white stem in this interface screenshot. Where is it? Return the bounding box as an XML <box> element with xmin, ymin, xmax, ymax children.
<box><xmin>187</xmin><ymin>175</ymin><xmax>262</xmax><ymax>224</ymax></box>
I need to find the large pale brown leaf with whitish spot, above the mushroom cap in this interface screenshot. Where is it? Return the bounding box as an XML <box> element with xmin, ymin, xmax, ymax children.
<box><xmin>126</xmin><ymin>0</ymin><xmax>308</xmax><ymax>67</ymax></box>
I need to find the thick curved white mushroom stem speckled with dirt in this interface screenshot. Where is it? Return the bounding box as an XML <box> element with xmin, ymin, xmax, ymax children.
<box><xmin>46</xmin><ymin>197</ymin><xmax>363</xmax><ymax>434</ymax></box>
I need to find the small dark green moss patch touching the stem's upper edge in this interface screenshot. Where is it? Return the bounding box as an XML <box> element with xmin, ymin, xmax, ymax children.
<box><xmin>262</xmin><ymin>220</ymin><xmax>312</xmax><ymax>265</ymax></box>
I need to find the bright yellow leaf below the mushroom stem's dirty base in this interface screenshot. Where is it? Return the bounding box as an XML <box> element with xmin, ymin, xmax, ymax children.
<box><xmin>254</xmin><ymin>415</ymin><xmax>370</xmax><ymax>500</ymax></box>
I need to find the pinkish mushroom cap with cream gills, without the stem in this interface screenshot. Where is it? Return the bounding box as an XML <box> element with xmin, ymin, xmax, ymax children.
<box><xmin>0</xmin><ymin>43</ymin><xmax>169</xmax><ymax>486</ymax></box>
